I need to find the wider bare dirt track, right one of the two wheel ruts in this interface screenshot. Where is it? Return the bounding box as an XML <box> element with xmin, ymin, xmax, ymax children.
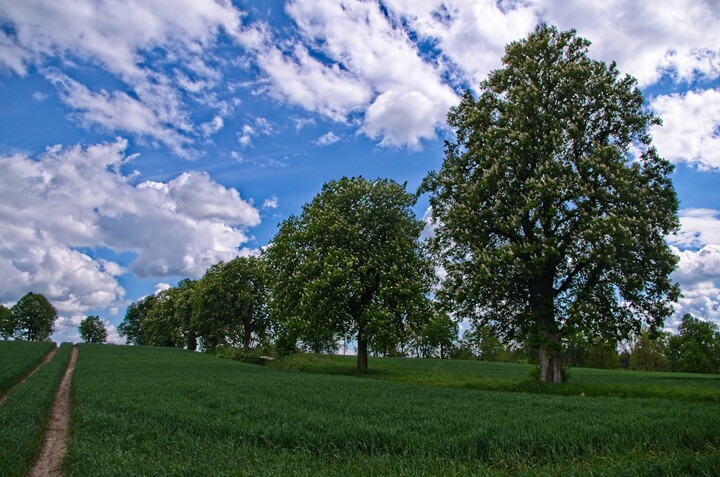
<box><xmin>29</xmin><ymin>347</ymin><xmax>78</xmax><ymax>477</ymax></box>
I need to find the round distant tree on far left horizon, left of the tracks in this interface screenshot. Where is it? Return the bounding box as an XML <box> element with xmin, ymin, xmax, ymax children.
<box><xmin>11</xmin><ymin>292</ymin><xmax>57</xmax><ymax>341</ymax></box>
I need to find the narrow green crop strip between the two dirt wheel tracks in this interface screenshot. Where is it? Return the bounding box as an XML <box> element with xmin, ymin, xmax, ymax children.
<box><xmin>0</xmin><ymin>343</ymin><xmax>72</xmax><ymax>477</ymax></box>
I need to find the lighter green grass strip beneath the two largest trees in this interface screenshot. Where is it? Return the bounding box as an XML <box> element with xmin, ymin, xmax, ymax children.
<box><xmin>270</xmin><ymin>354</ymin><xmax>720</xmax><ymax>403</ymax></box>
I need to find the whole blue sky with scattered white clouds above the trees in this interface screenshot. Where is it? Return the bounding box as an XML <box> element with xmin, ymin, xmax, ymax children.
<box><xmin>0</xmin><ymin>0</ymin><xmax>720</xmax><ymax>343</ymax></box>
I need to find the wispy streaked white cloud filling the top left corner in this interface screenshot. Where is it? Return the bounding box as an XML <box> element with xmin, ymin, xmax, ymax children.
<box><xmin>0</xmin><ymin>0</ymin><xmax>248</xmax><ymax>155</ymax></box>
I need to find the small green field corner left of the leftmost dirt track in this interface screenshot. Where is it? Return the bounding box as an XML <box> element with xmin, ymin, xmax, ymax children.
<box><xmin>0</xmin><ymin>341</ymin><xmax>55</xmax><ymax>396</ymax></box>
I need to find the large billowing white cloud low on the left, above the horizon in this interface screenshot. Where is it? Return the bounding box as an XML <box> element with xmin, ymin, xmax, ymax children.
<box><xmin>0</xmin><ymin>139</ymin><xmax>260</xmax><ymax>314</ymax></box>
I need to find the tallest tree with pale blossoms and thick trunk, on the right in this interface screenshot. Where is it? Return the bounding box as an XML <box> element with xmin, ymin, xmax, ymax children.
<box><xmin>420</xmin><ymin>26</ymin><xmax>679</xmax><ymax>383</ymax></box>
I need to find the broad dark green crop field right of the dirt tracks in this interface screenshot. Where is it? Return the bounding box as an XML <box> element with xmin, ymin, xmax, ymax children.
<box><xmin>64</xmin><ymin>345</ymin><xmax>720</xmax><ymax>476</ymax></box>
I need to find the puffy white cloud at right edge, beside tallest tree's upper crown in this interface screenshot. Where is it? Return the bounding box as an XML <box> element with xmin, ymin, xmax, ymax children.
<box><xmin>650</xmin><ymin>89</ymin><xmax>720</xmax><ymax>169</ymax></box>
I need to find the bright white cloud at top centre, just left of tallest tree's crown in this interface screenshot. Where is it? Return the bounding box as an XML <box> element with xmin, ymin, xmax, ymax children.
<box><xmin>250</xmin><ymin>0</ymin><xmax>458</xmax><ymax>147</ymax></box>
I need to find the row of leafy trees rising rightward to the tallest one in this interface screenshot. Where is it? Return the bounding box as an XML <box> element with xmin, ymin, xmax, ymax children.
<box><xmin>122</xmin><ymin>25</ymin><xmax>696</xmax><ymax>382</ymax></box>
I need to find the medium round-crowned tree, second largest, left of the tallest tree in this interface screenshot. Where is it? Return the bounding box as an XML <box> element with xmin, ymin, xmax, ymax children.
<box><xmin>267</xmin><ymin>177</ymin><xmax>434</xmax><ymax>370</ymax></box>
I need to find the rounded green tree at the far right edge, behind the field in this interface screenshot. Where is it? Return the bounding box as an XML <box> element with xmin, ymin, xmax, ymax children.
<box><xmin>668</xmin><ymin>313</ymin><xmax>720</xmax><ymax>373</ymax></box>
